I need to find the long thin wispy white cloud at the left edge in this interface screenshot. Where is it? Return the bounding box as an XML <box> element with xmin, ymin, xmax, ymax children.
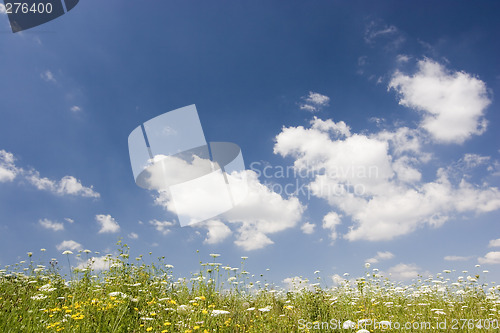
<box><xmin>0</xmin><ymin>150</ymin><xmax>100</xmax><ymax>198</ymax></box>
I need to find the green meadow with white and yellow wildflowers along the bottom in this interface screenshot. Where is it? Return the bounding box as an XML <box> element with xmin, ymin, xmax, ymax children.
<box><xmin>0</xmin><ymin>242</ymin><xmax>500</xmax><ymax>333</ymax></box>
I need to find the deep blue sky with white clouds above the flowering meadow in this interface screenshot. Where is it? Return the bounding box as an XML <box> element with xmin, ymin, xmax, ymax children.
<box><xmin>0</xmin><ymin>0</ymin><xmax>500</xmax><ymax>283</ymax></box>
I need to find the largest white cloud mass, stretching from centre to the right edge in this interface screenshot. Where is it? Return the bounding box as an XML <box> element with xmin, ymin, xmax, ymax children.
<box><xmin>274</xmin><ymin>114</ymin><xmax>500</xmax><ymax>241</ymax></box>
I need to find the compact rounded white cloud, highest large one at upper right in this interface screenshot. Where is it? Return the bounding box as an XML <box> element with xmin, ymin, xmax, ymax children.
<box><xmin>388</xmin><ymin>59</ymin><xmax>491</xmax><ymax>143</ymax></box>
